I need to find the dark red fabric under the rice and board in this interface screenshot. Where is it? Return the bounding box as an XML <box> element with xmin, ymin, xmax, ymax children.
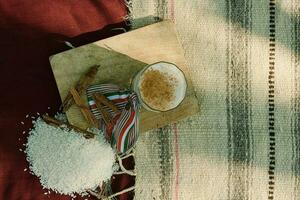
<box><xmin>0</xmin><ymin>0</ymin><xmax>133</xmax><ymax>200</ymax></box>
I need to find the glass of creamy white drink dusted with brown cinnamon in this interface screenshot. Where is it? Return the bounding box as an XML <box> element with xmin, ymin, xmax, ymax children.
<box><xmin>134</xmin><ymin>62</ymin><xmax>187</xmax><ymax>112</ymax></box>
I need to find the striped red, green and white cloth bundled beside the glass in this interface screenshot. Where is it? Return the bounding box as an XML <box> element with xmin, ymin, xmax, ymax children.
<box><xmin>86</xmin><ymin>84</ymin><xmax>140</xmax><ymax>154</ymax></box>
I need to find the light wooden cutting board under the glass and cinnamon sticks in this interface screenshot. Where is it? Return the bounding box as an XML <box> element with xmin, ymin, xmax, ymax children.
<box><xmin>50</xmin><ymin>21</ymin><xmax>199</xmax><ymax>132</ymax></box>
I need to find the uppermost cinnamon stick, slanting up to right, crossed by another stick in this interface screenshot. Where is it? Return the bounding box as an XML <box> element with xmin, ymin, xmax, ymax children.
<box><xmin>62</xmin><ymin>65</ymin><xmax>100</xmax><ymax>112</ymax></box>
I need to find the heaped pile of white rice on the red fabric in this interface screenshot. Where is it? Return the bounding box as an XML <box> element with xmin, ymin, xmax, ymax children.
<box><xmin>25</xmin><ymin>119</ymin><xmax>115</xmax><ymax>195</ymax></box>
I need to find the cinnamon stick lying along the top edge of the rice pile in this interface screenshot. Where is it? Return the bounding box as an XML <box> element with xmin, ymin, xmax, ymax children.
<box><xmin>42</xmin><ymin>115</ymin><xmax>95</xmax><ymax>139</ymax></box>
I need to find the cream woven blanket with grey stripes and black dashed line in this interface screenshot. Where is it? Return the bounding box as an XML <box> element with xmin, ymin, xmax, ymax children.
<box><xmin>129</xmin><ymin>0</ymin><xmax>300</xmax><ymax>200</ymax></box>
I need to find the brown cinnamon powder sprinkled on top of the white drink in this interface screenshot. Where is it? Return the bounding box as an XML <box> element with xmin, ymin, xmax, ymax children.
<box><xmin>140</xmin><ymin>69</ymin><xmax>177</xmax><ymax>110</ymax></box>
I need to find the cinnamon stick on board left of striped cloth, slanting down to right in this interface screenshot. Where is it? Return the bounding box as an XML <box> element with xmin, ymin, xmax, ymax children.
<box><xmin>70</xmin><ymin>87</ymin><xmax>98</xmax><ymax>128</ymax></box>
